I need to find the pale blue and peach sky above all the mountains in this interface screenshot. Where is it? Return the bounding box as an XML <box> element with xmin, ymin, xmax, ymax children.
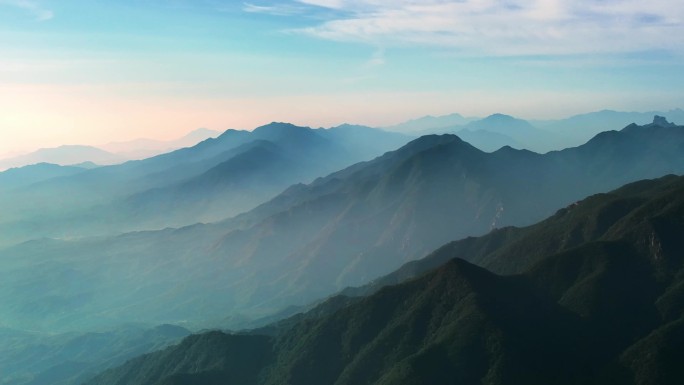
<box><xmin>0</xmin><ymin>0</ymin><xmax>684</xmax><ymax>155</ymax></box>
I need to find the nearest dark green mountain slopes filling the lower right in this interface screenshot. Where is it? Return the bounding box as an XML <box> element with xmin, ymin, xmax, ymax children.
<box><xmin>88</xmin><ymin>177</ymin><xmax>684</xmax><ymax>385</ymax></box>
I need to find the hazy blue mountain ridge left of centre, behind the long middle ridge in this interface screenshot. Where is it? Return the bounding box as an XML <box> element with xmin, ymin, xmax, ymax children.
<box><xmin>0</xmin><ymin>123</ymin><xmax>407</xmax><ymax>245</ymax></box>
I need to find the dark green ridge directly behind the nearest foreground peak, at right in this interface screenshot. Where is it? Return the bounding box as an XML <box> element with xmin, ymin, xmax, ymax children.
<box><xmin>345</xmin><ymin>175</ymin><xmax>683</xmax><ymax>296</ymax></box>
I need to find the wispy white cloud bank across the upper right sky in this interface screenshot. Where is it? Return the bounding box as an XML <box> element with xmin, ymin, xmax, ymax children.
<box><xmin>276</xmin><ymin>0</ymin><xmax>684</xmax><ymax>56</ymax></box>
